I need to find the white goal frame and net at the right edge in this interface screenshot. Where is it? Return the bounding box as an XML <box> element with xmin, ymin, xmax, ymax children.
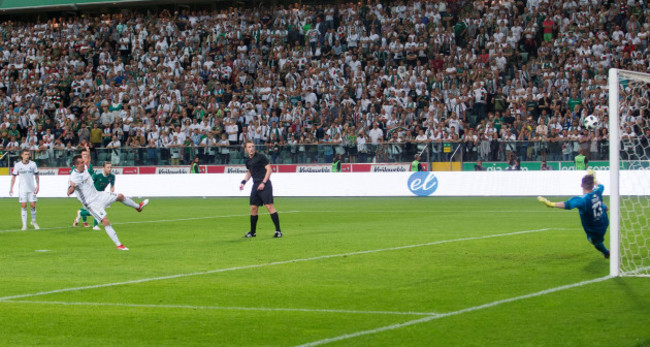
<box><xmin>609</xmin><ymin>69</ymin><xmax>650</xmax><ymax>277</ymax></box>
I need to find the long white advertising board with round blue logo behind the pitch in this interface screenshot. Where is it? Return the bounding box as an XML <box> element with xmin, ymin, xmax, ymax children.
<box><xmin>0</xmin><ymin>170</ymin><xmax>648</xmax><ymax>198</ymax></box>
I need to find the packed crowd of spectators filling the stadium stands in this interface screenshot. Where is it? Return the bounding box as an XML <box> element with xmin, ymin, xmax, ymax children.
<box><xmin>0</xmin><ymin>0</ymin><xmax>650</xmax><ymax>165</ymax></box>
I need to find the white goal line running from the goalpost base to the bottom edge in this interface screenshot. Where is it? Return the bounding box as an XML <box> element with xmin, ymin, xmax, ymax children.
<box><xmin>296</xmin><ymin>276</ymin><xmax>613</xmax><ymax>347</ymax></box>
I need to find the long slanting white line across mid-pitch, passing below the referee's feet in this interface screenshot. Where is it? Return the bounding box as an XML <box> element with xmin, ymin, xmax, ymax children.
<box><xmin>0</xmin><ymin>228</ymin><xmax>551</xmax><ymax>301</ymax></box>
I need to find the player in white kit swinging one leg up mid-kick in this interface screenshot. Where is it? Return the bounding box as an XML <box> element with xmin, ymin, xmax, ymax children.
<box><xmin>68</xmin><ymin>155</ymin><xmax>149</xmax><ymax>251</ymax></box>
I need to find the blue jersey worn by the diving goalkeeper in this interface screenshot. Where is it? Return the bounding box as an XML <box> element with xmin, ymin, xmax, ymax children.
<box><xmin>564</xmin><ymin>184</ymin><xmax>609</xmax><ymax>234</ymax></box>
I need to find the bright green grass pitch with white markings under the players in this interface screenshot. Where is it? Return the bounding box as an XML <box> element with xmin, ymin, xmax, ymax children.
<box><xmin>0</xmin><ymin>197</ymin><xmax>650</xmax><ymax>346</ymax></box>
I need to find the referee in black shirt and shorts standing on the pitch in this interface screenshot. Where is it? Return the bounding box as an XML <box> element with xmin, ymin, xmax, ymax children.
<box><xmin>239</xmin><ymin>140</ymin><xmax>282</xmax><ymax>238</ymax></box>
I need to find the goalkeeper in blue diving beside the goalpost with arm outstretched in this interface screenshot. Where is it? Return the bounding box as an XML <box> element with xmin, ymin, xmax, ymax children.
<box><xmin>537</xmin><ymin>170</ymin><xmax>609</xmax><ymax>259</ymax></box>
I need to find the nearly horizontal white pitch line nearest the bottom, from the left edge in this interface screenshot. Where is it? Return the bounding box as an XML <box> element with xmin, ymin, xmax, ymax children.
<box><xmin>4</xmin><ymin>300</ymin><xmax>438</xmax><ymax>317</ymax></box>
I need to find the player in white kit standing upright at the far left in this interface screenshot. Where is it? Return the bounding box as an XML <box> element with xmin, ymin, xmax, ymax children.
<box><xmin>9</xmin><ymin>150</ymin><xmax>39</xmax><ymax>230</ymax></box>
